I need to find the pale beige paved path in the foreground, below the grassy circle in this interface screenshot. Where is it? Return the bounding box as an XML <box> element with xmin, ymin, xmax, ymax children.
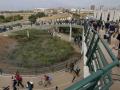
<box><xmin>0</xmin><ymin>71</ymin><xmax>80</xmax><ymax>90</ymax></box>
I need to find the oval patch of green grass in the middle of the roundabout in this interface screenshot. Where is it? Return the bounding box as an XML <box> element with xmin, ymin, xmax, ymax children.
<box><xmin>9</xmin><ymin>29</ymin><xmax>74</xmax><ymax>68</ymax></box>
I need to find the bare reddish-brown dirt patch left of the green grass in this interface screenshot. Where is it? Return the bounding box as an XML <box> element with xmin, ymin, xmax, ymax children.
<box><xmin>0</xmin><ymin>36</ymin><xmax>17</xmax><ymax>68</ymax></box>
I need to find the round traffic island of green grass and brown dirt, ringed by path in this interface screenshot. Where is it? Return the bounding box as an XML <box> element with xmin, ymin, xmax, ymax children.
<box><xmin>0</xmin><ymin>29</ymin><xmax>79</xmax><ymax>74</ymax></box>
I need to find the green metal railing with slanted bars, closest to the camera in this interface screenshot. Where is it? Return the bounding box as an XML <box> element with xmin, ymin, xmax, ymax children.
<box><xmin>65</xmin><ymin>22</ymin><xmax>119</xmax><ymax>90</ymax></box>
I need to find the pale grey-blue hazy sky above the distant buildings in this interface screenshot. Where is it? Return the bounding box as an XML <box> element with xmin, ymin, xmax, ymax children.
<box><xmin>0</xmin><ymin>0</ymin><xmax>120</xmax><ymax>10</ymax></box>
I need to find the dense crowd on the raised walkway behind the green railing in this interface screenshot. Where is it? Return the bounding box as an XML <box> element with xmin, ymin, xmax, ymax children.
<box><xmin>89</xmin><ymin>20</ymin><xmax>120</xmax><ymax>59</ymax></box>
